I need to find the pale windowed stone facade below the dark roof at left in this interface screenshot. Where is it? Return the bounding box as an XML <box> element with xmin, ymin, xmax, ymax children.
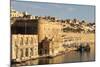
<box><xmin>12</xmin><ymin>34</ymin><xmax>38</xmax><ymax>62</ymax></box>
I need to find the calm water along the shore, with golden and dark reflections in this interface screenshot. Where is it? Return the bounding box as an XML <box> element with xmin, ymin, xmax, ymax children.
<box><xmin>12</xmin><ymin>43</ymin><xmax>95</xmax><ymax>67</ymax></box>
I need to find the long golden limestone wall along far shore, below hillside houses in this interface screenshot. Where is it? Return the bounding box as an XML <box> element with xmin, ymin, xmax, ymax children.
<box><xmin>63</xmin><ymin>32</ymin><xmax>95</xmax><ymax>42</ymax></box>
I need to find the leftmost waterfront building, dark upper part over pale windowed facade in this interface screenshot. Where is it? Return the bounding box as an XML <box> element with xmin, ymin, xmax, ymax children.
<box><xmin>11</xmin><ymin>19</ymin><xmax>38</xmax><ymax>62</ymax></box>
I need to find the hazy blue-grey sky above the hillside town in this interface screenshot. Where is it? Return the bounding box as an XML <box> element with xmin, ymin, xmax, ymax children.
<box><xmin>11</xmin><ymin>1</ymin><xmax>95</xmax><ymax>22</ymax></box>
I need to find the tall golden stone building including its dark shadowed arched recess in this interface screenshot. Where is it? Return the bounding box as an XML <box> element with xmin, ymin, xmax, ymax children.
<box><xmin>38</xmin><ymin>19</ymin><xmax>63</xmax><ymax>56</ymax></box>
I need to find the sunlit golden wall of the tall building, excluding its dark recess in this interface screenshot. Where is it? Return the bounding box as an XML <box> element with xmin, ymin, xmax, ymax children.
<box><xmin>38</xmin><ymin>19</ymin><xmax>62</xmax><ymax>56</ymax></box>
